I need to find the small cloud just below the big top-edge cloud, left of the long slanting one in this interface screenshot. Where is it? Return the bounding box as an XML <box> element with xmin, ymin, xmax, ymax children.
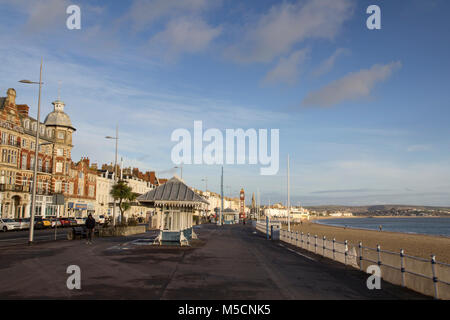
<box><xmin>263</xmin><ymin>49</ymin><xmax>309</xmax><ymax>85</ymax></box>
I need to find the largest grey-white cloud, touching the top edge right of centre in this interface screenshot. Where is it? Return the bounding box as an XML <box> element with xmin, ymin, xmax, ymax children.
<box><xmin>225</xmin><ymin>0</ymin><xmax>353</xmax><ymax>62</ymax></box>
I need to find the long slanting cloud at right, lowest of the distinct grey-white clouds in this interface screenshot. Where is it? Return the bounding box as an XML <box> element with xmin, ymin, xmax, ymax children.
<box><xmin>302</xmin><ymin>62</ymin><xmax>401</xmax><ymax>107</ymax></box>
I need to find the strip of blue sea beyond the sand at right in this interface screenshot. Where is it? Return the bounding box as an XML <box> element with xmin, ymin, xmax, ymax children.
<box><xmin>316</xmin><ymin>217</ymin><xmax>450</xmax><ymax>237</ymax></box>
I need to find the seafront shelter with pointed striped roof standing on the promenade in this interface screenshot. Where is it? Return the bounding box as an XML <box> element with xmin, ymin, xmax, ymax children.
<box><xmin>137</xmin><ymin>176</ymin><xmax>208</xmax><ymax>245</ymax></box>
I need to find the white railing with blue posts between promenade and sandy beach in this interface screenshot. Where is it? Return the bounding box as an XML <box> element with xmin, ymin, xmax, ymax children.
<box><xmin>258</xmin><ymin>228</ymin><xmax>450</xmax><ymax>300</ymax></box>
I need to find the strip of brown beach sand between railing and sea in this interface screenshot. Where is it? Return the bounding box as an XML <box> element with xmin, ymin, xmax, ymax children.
<box><xmin>283</xmin><ymin>221</ymin><xmax>450</xmax><ymax>263</ymax></box>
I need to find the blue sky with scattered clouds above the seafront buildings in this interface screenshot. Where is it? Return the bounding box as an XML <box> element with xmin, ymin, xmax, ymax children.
<box><xmin>0</xmin><ymin>0</ymin><xmax>450</xmax><ymax>206</ymax></box>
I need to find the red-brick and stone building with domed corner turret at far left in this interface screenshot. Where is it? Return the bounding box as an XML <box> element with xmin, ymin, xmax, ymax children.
<box><xmin>0</xmin><ymin>89</ymin><xmax>95</xmax><ymax>218</ymax></box>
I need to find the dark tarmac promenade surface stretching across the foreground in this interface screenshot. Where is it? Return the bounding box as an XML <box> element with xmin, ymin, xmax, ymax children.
<box><xmin>0</xmin><ymin>225</ymin><xmax>426</xmax><ymax>300</ymax></box>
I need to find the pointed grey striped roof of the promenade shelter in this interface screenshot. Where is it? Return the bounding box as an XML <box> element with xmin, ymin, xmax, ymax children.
<box><xmin>137</xmin><ymin>177</ymin><xmax>209</xmax><ymax>204</ymax></box>
